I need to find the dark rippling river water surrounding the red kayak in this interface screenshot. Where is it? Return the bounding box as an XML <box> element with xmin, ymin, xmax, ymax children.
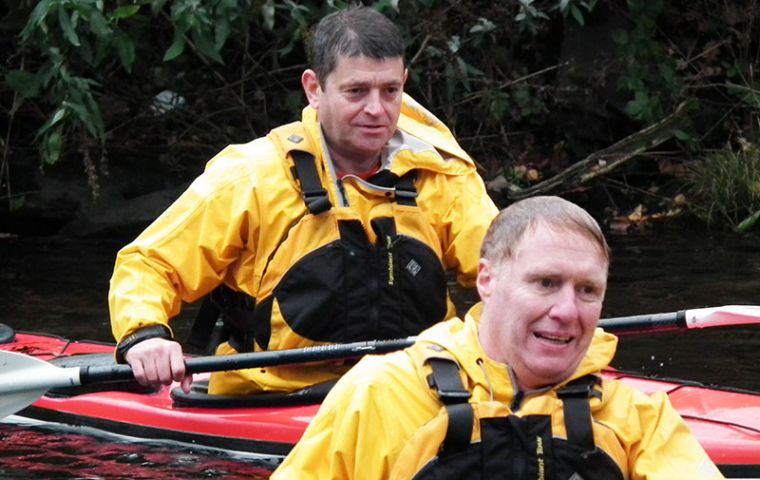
<box><xmin>0</xmin><ymin>226</ymin><xmax>760</xmax><ymax>479</ymax></box>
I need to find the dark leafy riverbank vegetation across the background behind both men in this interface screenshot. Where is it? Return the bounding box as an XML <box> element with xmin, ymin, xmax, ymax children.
<box><xmin>0</xmin><ymin>0</ymin><xmax>760</xmax><ymax>232</ymax></box>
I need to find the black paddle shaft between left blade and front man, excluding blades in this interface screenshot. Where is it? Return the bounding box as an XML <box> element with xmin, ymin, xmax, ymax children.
<box><xmin>79</xmin><ymin>337</ymin><xmax>415</xmax><ymax>385</ymax></box>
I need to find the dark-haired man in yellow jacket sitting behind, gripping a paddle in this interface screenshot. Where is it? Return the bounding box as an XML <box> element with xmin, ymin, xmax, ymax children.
<box><xmin>109</xmin><ymin>7</ymin><xmax>497</xmax><ymax>394</ymax></box>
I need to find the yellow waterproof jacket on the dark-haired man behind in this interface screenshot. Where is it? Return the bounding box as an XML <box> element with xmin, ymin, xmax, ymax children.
<box><xmin>109</xmin><ymin>96</ymin><xmax>497</xmax><ymax>394</ymax></box>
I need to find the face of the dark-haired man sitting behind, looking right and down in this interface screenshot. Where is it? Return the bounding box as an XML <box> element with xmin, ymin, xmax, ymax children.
<box><xmin>302</xmin><ymin>56</ymin><xmax>406</xmax><ymax>171</ymax></box>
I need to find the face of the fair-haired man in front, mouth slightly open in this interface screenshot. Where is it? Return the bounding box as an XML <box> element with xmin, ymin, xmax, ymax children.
<box><xmin>478</xmin><ymin>222</ymin><xmax>608</xmax><ymax>388</ymax></box>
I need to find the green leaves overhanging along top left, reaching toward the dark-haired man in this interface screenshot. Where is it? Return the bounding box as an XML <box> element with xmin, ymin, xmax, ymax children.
<box><xmin>5</xmin><ymin>0</ymin><xmax>319</xmax><ymax>186</ymax></box>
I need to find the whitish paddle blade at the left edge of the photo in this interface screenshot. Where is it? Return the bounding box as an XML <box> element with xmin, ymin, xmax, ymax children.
<box><xmin>0</xmin><ymin>350</ymin><xmax>81</xmax><ymax>418</ymax></box>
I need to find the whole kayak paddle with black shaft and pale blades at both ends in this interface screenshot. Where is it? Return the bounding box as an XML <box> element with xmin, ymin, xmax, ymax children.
<box><xmin>0</xmin><ymin>305</ymin><xmax>760</xmax><ymax>418</ymax></box>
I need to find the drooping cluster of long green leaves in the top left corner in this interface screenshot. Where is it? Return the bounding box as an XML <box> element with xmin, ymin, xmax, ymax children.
<box><xmin>6</xmin><ymin>0</ymin><xmax>137</xmax><ymax>164</ymax></box>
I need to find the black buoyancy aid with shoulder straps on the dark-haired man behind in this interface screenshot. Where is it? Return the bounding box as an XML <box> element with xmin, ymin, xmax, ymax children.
<box><xmin>188</xmin><ymin>150</ymin><xmax>447</xmax><ymax>352</ymax></box>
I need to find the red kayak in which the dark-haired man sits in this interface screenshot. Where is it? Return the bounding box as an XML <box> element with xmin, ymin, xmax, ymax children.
<box><xmin>0</xmin><ymin>327</ymin><xmax>760</xmax><ymax>478</ymax></box>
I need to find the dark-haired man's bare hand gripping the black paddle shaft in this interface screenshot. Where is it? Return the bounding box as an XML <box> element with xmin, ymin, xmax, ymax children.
<box><xmin>124</xmin><ymin>338</ymin><xmax>193</xmax><ymax>393</ymax></box>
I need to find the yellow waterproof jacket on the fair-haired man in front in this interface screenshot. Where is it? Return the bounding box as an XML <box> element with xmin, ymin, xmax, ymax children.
<box><xmin>271</xmin><ymin>306</ymin><xmax>723</xmax><ymax>480</ymax></box>
